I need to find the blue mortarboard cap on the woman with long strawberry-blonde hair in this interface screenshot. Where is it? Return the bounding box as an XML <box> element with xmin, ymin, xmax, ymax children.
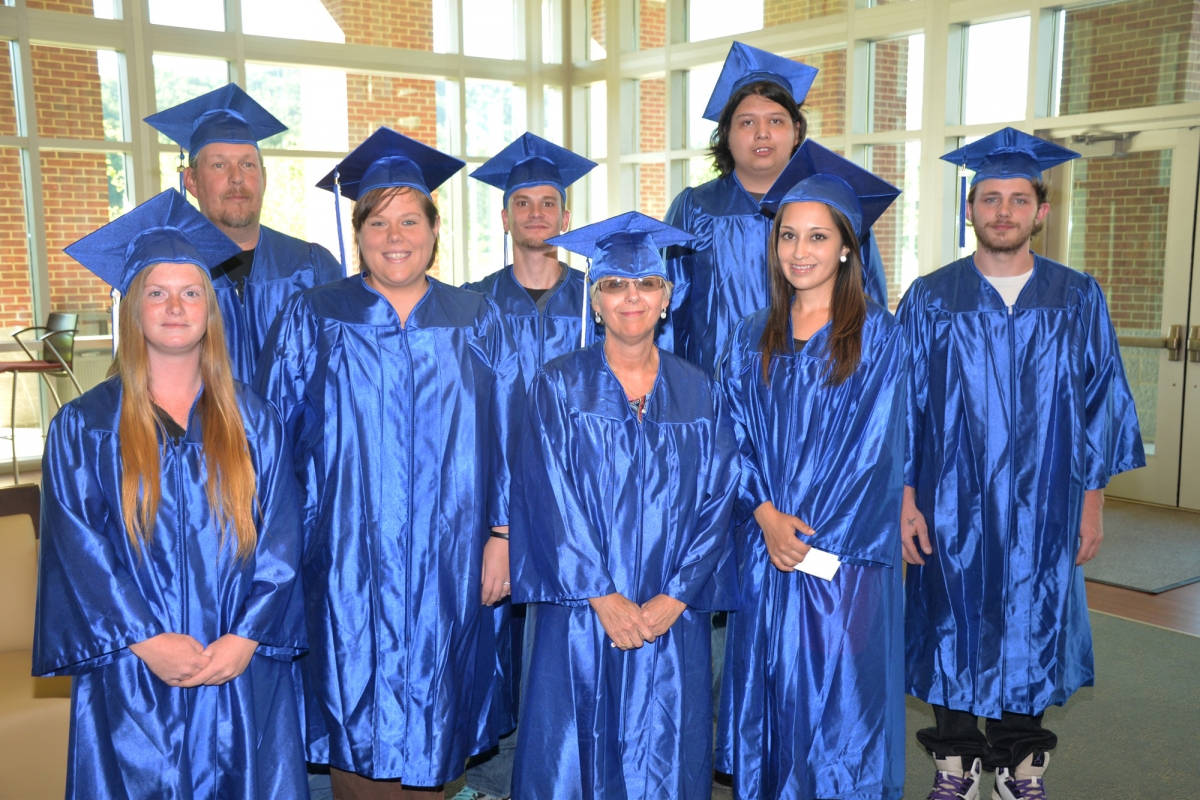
<box><xmin>65</xmin><ymin>188</ymin><xmax>241</xmax><ymax>295</ymax></box>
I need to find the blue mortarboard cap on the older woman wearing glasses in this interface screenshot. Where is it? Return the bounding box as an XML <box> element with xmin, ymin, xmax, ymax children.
<box><xmin>546</xmin><ymin>211</ymin><xmax>696</xmax><ymax>281</ymax></box>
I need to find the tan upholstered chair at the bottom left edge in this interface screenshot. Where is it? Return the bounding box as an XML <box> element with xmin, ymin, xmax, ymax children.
<box><xmin>0</xmin><ymin>485</ymin><xmax>71</xmax><ymax>800</ymax></box>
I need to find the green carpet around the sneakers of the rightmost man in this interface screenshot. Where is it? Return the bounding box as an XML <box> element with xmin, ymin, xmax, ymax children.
<box><xmin>905</xmin><ymin>612</ymin><xmax>1200</xmax><ymax>800</ymax></box>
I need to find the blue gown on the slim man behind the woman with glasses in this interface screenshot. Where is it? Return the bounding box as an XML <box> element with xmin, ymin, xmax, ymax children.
<box><xmin>462</xmin><ymin>264</ymin><xmax>598</xmax><ymax>738</ymax></box>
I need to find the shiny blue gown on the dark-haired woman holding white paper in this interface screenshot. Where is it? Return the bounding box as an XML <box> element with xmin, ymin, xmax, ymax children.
<box><xmin>718</xmin><ymin>302</ymin><xmax>908</xmax><ymax>800</ymax></box>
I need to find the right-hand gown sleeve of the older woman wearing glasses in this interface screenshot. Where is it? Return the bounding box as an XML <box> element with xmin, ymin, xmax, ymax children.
<box><xmin>662</xmin><ymin>383</ymin><xmax>740</xmax><ymax>612</ymax></box>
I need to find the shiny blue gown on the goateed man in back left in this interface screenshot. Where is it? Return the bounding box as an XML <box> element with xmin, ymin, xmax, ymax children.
<box><xmin>212</xmin><ymin>225</ymin><xmax>344</xmax><ymax>384</ymax></box>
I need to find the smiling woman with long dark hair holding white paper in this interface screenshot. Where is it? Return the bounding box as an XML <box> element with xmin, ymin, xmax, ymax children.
<box><xmin>719</xmin><ymin>142</ymin><xmax>908</xmax><ymax>800</ymax></box>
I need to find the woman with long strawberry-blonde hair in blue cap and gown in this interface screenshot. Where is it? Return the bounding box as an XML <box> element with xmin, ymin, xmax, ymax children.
<box><xmin>34</xmin><ymin>190</ymin><xmax>307</xmax><ymax>800</ymax></box>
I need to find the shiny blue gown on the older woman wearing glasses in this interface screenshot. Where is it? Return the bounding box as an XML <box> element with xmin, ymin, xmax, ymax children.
<box><xmin>511</xmin><ymin>343</ymin><xmax>738</xmax><ymax>800</ymax></box>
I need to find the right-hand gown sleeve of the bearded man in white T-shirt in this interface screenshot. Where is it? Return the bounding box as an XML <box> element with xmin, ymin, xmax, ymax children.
<box><xmin>1085</xmin><ymin>275</ymin><xmax>1146</xmax><ymax>489</ymax></box>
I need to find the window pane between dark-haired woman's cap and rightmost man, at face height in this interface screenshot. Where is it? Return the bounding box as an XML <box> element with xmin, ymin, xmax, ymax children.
<box><xmin>866</xmin><ymin>142</ymin><xmax>920</xmax><ymax>311</ymax></box>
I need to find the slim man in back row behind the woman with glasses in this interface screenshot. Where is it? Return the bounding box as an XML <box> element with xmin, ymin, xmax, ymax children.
<box><xmin>455</xmin><ymin>133</ymin><xmax>596</xmax><ymax>800</ymax></box>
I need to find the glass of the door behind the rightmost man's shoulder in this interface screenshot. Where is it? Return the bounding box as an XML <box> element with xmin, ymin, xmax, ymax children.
<box><xmin>1067</xmin><ymin>150</ymin><xmax>1171</xmax><ymax>456</ymax></box>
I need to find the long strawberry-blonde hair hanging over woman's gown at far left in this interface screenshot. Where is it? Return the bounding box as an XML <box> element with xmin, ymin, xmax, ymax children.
<box><xmin>108</xmin><ymin>266</ymin><xmax>258</xmax><ymax>559</ymax></box>
